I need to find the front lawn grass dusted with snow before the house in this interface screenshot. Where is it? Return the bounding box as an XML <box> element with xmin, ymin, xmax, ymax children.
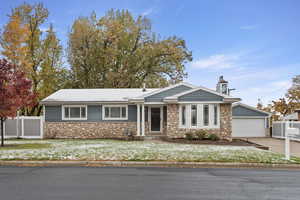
<box><xmin>0</xmin><ymin>139</ymin><xmax>296</xmax><ymax>163</ymax></box>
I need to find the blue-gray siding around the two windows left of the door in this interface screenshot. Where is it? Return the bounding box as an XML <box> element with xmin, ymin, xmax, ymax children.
<box><xmin>45</xmin><ymin>105</ymin><xmax>137</xmax><ymax>122</ymax></box>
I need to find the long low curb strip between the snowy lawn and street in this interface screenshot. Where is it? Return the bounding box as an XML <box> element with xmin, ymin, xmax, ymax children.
<box><xmin>0</xmin><ymin>160</ymin><xmax>300</xmax><ymax>170</ymax></box>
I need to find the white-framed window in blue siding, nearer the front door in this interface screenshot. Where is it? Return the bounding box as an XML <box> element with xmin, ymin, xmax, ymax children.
<box><xmin>102</xmin><ymin>105</ymin><xmax>127</xmax><ymax>120</ymax></box>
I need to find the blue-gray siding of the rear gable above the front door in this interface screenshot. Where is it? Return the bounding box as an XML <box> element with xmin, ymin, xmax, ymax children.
<box><xmin>145</xmin><ymin>85</ymin><xmax>192</xmax><ymax>102</ymax></box>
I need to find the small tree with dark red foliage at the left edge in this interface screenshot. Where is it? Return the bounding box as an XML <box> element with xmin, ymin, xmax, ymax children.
<box><xmin>0</xmin><ymin>59</ymin><xmax>36</xmax><ymax>146</ymax></box>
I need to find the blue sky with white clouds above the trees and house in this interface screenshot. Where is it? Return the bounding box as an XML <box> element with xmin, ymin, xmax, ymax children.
<box><xmin>0</xmin><ymin>0</ymin><xmax>300</xmax><ymax>105</ymax></box>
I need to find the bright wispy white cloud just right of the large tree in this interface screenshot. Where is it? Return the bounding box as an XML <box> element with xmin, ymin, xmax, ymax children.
<box><xmin>191</xmin><ymin>54</ymin><xmax>241</xmax><ymax>70</ymax></box>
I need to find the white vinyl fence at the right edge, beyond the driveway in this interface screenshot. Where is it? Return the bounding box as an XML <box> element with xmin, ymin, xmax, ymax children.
<box><xmin>272</xmin><ymin>121</ymin><xmax>300</xmax><ymax>141</ymax></box>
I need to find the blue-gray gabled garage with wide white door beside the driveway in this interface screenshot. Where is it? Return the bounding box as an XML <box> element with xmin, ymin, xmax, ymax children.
<box><xmin>232</xmin><ymin>103</ymin><xmax>270</xmax><ymax>137</ymax></box>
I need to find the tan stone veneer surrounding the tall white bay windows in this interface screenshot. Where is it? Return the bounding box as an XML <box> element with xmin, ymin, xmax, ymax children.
<box><xmin>166</xmin><ymin>104</ymin><xmax>232</xmax><ymax>140</ymax></box>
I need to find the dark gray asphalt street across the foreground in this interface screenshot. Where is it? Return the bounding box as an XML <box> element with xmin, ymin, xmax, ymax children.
<box><xmin>0</xmin><ymin>167</ymin><xmax>300</xmax><ymax>200</ymax></box>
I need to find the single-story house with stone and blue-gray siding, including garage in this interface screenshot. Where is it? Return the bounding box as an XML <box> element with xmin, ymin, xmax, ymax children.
<box><xmin>41</xmin><ymin>76</ymin><xmax>269</xmax><ymax>140</ymax></box>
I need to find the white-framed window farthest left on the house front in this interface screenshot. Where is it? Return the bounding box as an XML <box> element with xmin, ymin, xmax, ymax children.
<box><xmin>62</xmin><ymin>105</ymin><xmax>87</xmax><ymax>120</ymax></box>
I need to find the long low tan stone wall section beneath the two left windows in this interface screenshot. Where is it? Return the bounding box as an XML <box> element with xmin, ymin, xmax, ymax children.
<box><xmin>44</xmin><ymin>122</ymin><xmax>136</xmax><ymax>138</ymax></box>
